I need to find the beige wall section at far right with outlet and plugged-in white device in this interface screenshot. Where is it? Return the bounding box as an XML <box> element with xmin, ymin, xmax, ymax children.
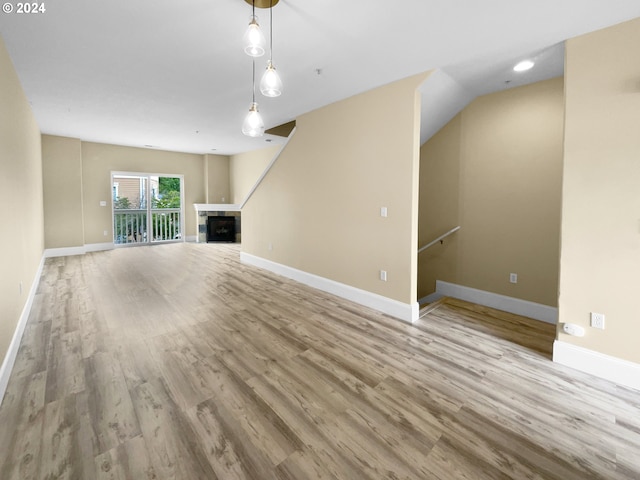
<box><xmin>558</xmin><ymin>19</ymin><xmax>640</xmax><ymax>363</ymax></box>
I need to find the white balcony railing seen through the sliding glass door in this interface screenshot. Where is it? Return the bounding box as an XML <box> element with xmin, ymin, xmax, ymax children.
<box><xmin>113</xmin><ymin>208</ymin><xmax>182</xmax><ymax>245</ymax></box>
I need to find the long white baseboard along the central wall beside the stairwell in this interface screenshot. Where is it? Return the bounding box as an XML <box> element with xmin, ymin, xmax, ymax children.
<box><xmin>240</xmin><ymin>252</ymin><xmax>419</xmax><ymax>322</ymax></box>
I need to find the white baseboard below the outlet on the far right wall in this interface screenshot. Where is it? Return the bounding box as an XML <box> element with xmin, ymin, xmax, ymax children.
<box><xmin>553</xmin><ymin>340</ymin><xmax>640</xmax><ymax>390</ymax></box>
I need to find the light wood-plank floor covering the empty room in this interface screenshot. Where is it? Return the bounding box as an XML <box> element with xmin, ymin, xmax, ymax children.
<box><xmin>0</xmin><ymin>244</ymin><xmax>640</xmax><ymax>480</ymax></box>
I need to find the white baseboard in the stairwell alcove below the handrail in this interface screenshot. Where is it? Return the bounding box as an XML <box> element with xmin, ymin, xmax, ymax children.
<box><xmin>436</xmin><ymin>280</ymin><xmax>558</xmax><ymax>325</ymax></box>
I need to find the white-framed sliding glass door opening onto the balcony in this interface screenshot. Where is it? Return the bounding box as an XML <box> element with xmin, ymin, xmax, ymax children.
<box><xmin>111</xmin><ymin>172</ymin><xmax>184</xmax><ymax>245</ymax></box>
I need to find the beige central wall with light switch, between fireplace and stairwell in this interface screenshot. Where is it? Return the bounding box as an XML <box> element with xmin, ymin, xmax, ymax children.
<box><xmin>242</xmin><ymin>74</ymin><xmax>427</xmax><ymax>303</ymax></box>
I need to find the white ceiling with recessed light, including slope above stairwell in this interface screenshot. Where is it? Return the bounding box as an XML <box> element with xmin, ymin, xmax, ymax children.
<box><xmin>0</xmin><ymin>0</ymin><xmax>640</xmax><ymax>154</ymax></box>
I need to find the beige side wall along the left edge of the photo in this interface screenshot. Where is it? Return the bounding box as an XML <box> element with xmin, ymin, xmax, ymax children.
<box><xmin>0</xmin><ymin>38</ymin><xmax>44</xmax><ymax>362</ymax></box>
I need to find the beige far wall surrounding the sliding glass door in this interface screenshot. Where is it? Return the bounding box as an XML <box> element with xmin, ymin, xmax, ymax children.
<box><xmin>82</xmin><ymin>142</ymin><xmax>205</xmax><ymax>244</ymax></box>
